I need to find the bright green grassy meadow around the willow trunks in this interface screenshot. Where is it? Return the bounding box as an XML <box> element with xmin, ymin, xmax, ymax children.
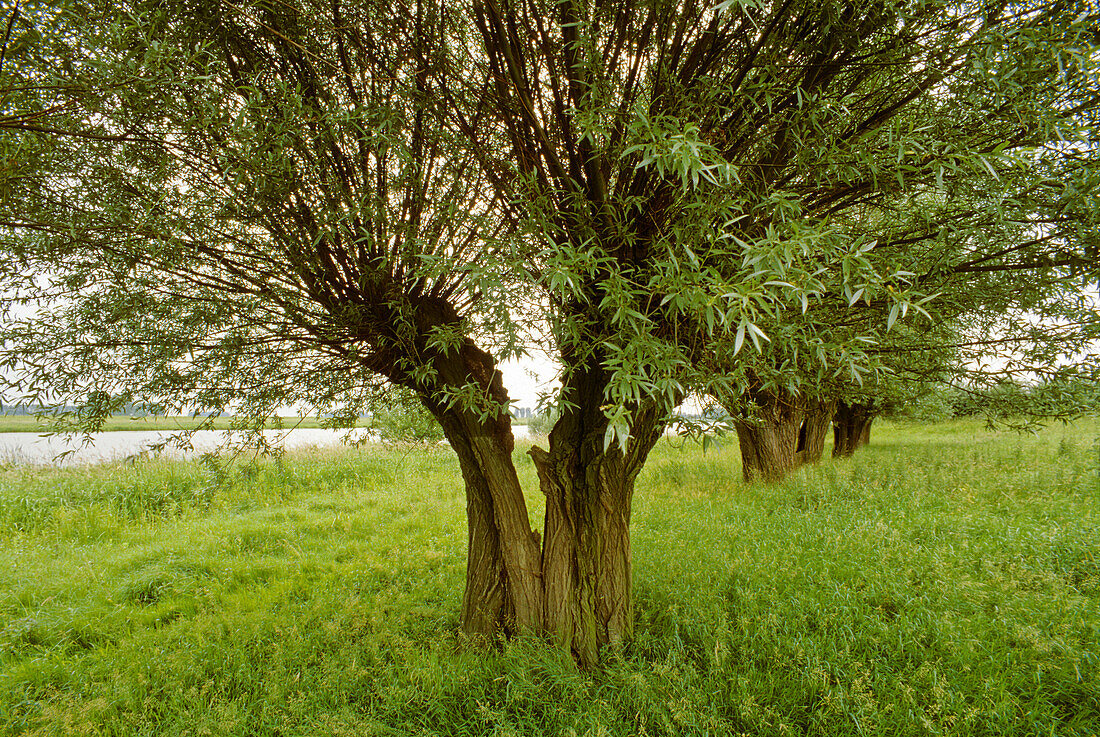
<box><xmin>0</xmin><ymin>420</ymin><xmax>1100</xmax><ymax>737</ymax></box>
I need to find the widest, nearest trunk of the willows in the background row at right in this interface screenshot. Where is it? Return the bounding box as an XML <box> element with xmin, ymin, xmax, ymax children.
<box><xmin>730</xmin><ymin>392</ymin><xmax>805</xmax><ymax>483</ymax></box>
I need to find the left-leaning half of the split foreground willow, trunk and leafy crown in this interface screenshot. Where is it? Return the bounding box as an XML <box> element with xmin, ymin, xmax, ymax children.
<box><xmin>2</xmin><ymin>0</ymin><xmax>543</xmax><ymax>635</ymax></box>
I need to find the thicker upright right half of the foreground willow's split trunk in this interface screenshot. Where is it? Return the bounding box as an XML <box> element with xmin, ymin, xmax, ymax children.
<box><xmin>530</xmin><ymin>381</ymin><xmax>663</xmax><ymax>668</ymax></box>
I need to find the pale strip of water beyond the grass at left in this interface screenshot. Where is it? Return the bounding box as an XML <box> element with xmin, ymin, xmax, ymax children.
<box><xmin>0</xmin><ymin>425</ymin><xmax>527</xmax><ymax>466</ymax></box>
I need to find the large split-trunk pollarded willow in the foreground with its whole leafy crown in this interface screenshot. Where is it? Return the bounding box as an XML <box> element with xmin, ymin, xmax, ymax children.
<box><xmin>0</xmin><ymin>0</ymin><xmax>1100</xmax><ymax>667</ymax></box>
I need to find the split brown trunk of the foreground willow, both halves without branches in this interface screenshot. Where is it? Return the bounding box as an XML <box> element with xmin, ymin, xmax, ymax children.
<box><xmin>421</xmin><ymin>344</ymin><xmax>663</xmax><ymax>668</ymax></box>
